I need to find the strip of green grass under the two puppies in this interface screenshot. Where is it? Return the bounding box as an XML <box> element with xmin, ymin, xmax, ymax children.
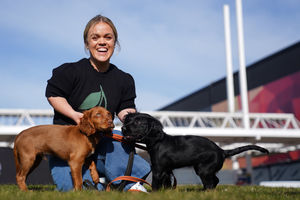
<box><xmin>0</xmin><ymin>185</ymin><xmax>300</xmax><ymax>200</ymax></box>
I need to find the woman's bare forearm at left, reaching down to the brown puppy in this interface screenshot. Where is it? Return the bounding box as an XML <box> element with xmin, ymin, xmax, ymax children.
<box><xmin>48</xmin><ymin>97</ymin><xmax>83</xmax><ymax>124</ymax></box>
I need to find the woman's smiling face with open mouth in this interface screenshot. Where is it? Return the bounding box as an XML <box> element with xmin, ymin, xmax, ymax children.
<box><xmin>86</xmin><ymin>22</ymin><xmax>115</xmax><ymax>63</ymax></box>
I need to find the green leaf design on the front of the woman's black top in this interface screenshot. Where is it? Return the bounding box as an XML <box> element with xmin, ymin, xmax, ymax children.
<box><xmin>79</xmin><ymin>85</ymin><xmax>107</xmax><ymax>110</ymax></box>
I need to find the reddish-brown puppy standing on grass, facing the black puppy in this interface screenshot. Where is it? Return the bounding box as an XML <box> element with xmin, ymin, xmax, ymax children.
<box><xmin>14</xmin><ymin>107</ymin><xmax>114</xmax><ymax>190</ymax></box>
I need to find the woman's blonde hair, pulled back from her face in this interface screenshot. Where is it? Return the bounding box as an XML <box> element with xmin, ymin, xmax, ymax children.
<box><xmin>83</xmin><ymin>15</ymin><xmax>120</xmax><ymax>48</ymax></box>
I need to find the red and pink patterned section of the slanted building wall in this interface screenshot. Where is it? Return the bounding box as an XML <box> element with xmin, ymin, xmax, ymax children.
<box><xmin>212</xmin><ymin>71</ymin><xmax>300</xmax><ymax>120</ymax></box>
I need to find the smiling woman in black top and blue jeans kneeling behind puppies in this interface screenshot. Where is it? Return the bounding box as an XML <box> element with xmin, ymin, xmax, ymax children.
<box><xmin>46</xmin><ymin>15</ymin><xmax>150</xmax><ymax>191</ymax></box>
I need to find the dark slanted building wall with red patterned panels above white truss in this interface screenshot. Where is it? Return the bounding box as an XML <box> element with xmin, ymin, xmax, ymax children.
<box><xmin>159</xmin><ymin>42</ymin><xmax>300</xmax><ymax>119</ymax></box>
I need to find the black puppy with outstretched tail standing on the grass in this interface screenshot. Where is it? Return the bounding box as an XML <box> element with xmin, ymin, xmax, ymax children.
<box><xmin>122</xmin><ymin>113</ymin><xmax>269</xmax><ymax>190</ymax></box>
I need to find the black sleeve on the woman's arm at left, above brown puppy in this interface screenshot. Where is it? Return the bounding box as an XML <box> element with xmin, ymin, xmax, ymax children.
<box><xmin>46</xmin><ymin>64</ymin><xmax>74</xmax><ymax>98</ymax></box>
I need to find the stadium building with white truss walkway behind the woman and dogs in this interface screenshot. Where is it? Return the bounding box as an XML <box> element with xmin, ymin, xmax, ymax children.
<box><xmin>0</xmin><ymin>0</ymin><xmax>300</xmax><ymax>191</ymax></box>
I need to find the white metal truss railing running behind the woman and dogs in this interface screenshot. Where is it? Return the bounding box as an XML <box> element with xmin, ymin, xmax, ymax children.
<box><xmin>0</xmin><ymin>109</ymin><xmax>300</xmax><ymax>150</ymax></box>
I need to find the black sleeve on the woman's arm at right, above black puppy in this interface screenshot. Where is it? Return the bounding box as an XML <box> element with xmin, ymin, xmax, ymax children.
<box><xmin>117</xmin><ymin>74</ymin><xmax>136</xmax><ymax>114</ymax></box>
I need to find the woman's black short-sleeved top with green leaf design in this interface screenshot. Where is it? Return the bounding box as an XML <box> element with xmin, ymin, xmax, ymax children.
<box><xmin>46</xmin><ymin>58</ymin><xmax>136</xmax><ymax>124</ymax></box>
